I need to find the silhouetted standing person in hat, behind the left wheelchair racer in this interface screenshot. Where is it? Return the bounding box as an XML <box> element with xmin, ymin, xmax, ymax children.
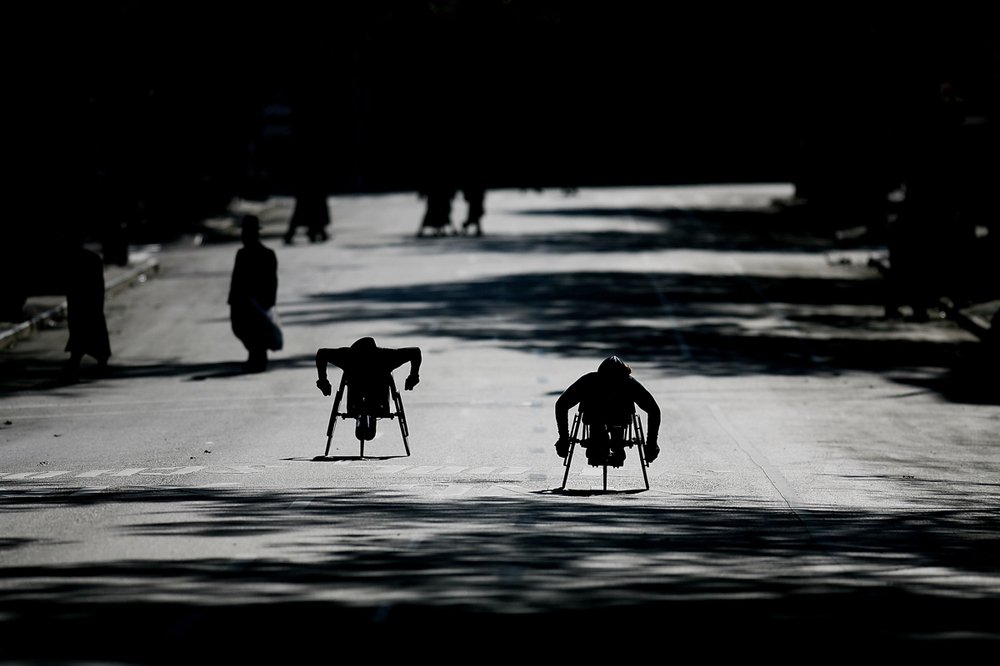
<box><xmin>228</xmin><ymin>215</ymin><xmax>282</xmax><ymax>372</ymax></box>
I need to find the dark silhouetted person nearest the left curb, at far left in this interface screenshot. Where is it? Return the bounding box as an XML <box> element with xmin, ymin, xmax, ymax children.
<box><xmin>63</xmin><ymin>243</ymin><xmax>111</xmax><ymax>377</ymax></box>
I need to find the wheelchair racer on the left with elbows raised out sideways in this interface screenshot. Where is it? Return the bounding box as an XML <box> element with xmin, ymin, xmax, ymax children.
<box><xmin>316</xmin><ymin>337</ymin><xmax>421</xmax><ymax>441</ymax></box>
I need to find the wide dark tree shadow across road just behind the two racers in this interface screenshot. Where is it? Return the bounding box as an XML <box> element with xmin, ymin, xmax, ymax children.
<box><xmin>283</xmin><ymin>271</ymin><xmax>995</xmax><ymax>403</ymax></box>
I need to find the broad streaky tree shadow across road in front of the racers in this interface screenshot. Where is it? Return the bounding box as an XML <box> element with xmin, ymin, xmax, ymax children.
<box><xmin>0</xmin><ymin>480</ymin><xmax>1000</xmax><ymax>663</ymax></box>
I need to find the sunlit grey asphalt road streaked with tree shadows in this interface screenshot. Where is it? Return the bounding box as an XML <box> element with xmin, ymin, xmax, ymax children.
<box><xmin>0</xmin><ymin>185</ymin><xmax>1000</xmax><ymax>663</ymax></box>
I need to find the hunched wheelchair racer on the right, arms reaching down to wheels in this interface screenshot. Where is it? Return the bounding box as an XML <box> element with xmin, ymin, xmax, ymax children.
<box><xmin>556</xmin><ymin>356</ymin><xmax>660</xmax><ymax>467</ymax></box>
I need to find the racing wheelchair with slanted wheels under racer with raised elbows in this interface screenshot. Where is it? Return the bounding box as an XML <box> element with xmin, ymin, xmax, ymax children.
<box><xmin>323</xmin><ymin>373</ymin><xmax>410</xmax><ymax>458</ymax></box>
